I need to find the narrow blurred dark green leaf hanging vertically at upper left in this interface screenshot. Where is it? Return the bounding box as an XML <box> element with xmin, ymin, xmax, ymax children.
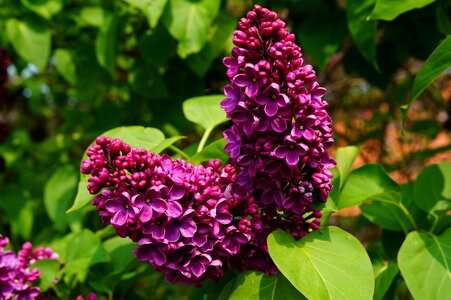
<box><xmin>96</xmin><ymin>14</ymin><xmax>119</xmax><ymax>76</ymax></box>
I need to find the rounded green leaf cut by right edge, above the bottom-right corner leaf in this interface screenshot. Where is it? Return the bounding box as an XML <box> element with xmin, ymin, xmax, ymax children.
<box><xmin>415</xmin><ymin>162</ymin><xmax>451</xmax><ymax>212</ymax></box>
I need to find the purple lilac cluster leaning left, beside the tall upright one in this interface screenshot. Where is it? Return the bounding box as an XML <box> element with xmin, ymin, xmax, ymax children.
<box><xmin>81</xmin><ymin>136</ymin><xmax>251</xmax><ymax>285</ymax></box>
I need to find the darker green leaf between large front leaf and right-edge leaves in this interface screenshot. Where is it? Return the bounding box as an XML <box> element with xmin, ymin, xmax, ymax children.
<box><xmin>361</xmin><ymin>192</ymin><xmax>416</xmax><ymax>233</ymax></box>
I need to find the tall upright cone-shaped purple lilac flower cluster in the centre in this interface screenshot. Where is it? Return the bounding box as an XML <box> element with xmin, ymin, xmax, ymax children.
<box><xmin>221</xmin><ymin>5</ymin><xmax>335</xmax><ymax>273</ymax></box>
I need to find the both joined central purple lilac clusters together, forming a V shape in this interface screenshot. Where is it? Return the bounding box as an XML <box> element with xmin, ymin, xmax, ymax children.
<box><xmin>81</xmin><ymin>5</ymin><xmax>335</xmax><ymax>285</ymax></box>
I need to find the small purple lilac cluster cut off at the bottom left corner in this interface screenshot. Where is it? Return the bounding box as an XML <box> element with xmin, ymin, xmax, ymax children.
<box><xmin>0</xmin><ymin>234</ymin><xmax>58</xmax><ymax>300</ymax></box>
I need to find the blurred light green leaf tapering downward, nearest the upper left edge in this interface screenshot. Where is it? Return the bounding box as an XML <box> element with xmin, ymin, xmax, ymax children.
<box><xmin>6</xmin><ymin>16</ymin><xmax>52</xmax><ymax>72</ymax></box>
